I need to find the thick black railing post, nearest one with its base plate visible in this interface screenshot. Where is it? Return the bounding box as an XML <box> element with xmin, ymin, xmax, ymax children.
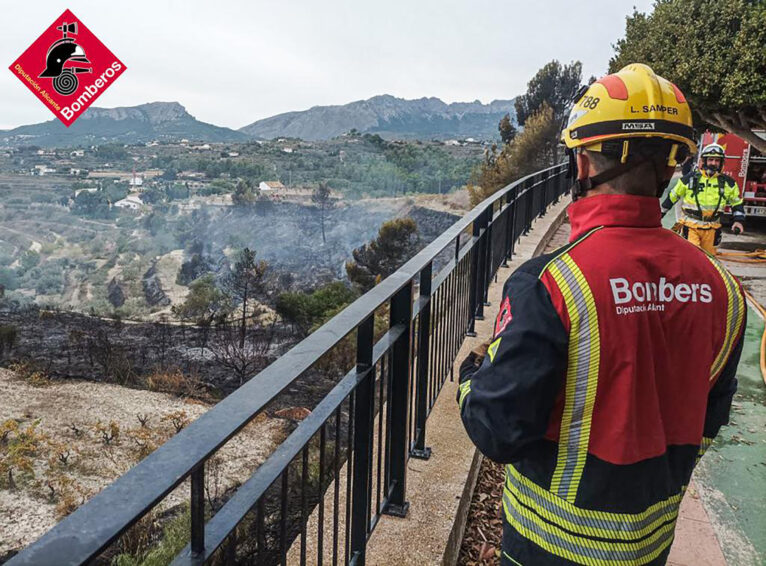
<box><xmin>385</xmin><ymin>280</ymin><xmax>412</xmax><ymax>517</ymax></box>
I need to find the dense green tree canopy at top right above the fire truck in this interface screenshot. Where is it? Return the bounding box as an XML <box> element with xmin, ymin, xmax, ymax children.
<box><xmin>609</xmin><ymin>0</ymin><xmax>766</xmax><ymax>153</ymax></box>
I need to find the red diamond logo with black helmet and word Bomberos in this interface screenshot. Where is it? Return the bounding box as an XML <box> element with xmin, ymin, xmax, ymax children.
<box><xmin>10</xmin><ymin>10</ymin><xmax>126</xmax><ymax>127</ymax></box>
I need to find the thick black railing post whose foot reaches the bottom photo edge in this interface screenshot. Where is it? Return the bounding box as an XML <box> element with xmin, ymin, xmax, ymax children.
<box><xmin>351</xmin><ymin>314</ymin><xmax>375</xmax><ymax>566</ymax></box>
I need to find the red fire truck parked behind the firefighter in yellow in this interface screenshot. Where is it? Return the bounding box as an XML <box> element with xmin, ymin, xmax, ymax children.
<box><xmin>700</xmin><ymin>132</ymin><xmax>766</xmax><ymax>217</ymax></box>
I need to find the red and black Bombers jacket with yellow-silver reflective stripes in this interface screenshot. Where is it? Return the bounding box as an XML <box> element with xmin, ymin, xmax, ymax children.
<box><xmin>458</xmin><ymin>195</ymin><xmax>746</xmax><ymax>566</ymax></box>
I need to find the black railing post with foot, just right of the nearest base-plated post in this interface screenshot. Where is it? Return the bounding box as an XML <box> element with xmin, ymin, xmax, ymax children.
<box><xmin>410</xmin><ymin>262</ymin><xmax>433</xmax><ymax>460</ymax></box>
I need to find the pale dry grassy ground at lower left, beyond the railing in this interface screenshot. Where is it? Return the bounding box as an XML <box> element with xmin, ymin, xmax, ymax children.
<box><xmin>0</xmin><ymin>369</ymin><xmax>289</xmax><ymax>555</ymax></box>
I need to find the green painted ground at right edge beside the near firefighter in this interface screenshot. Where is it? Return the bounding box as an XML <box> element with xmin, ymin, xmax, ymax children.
<box><xmin>695</xmin><ymin>309</ymin><xmax>766</xmax><ymax>566</ymax></box>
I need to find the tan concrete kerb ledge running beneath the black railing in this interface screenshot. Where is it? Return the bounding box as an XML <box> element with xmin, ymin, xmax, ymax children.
<box><xmin>288</xmin><ymin>196</ymin><xmax>569</xmax><ymax>566</ymax></box>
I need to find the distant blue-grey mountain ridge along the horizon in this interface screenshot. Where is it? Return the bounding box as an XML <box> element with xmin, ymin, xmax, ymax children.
<box><xmin>0</xmin><ymin>94</ymin><xmax>516</xmax><ymax>147</ymax></box>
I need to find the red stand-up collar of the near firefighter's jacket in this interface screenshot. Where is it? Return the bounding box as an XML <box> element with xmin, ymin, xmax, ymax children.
<box><xmin>567</xmin><ymin>195</ymin><xmax>662</xmax><ymax>242</ymax></box>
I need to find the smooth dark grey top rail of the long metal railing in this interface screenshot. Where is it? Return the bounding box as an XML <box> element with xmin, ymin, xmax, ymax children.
<box><xmin>8</xmin><ymin>165</ymin><xmax>564</xmax><ymax>566</ymax></box>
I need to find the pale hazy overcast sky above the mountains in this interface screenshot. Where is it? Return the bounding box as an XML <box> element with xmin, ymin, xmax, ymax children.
<box><xmin>0</xmin><ymin>0</ymin><xmax>652</xmax><ymax>129</ymax></box>
